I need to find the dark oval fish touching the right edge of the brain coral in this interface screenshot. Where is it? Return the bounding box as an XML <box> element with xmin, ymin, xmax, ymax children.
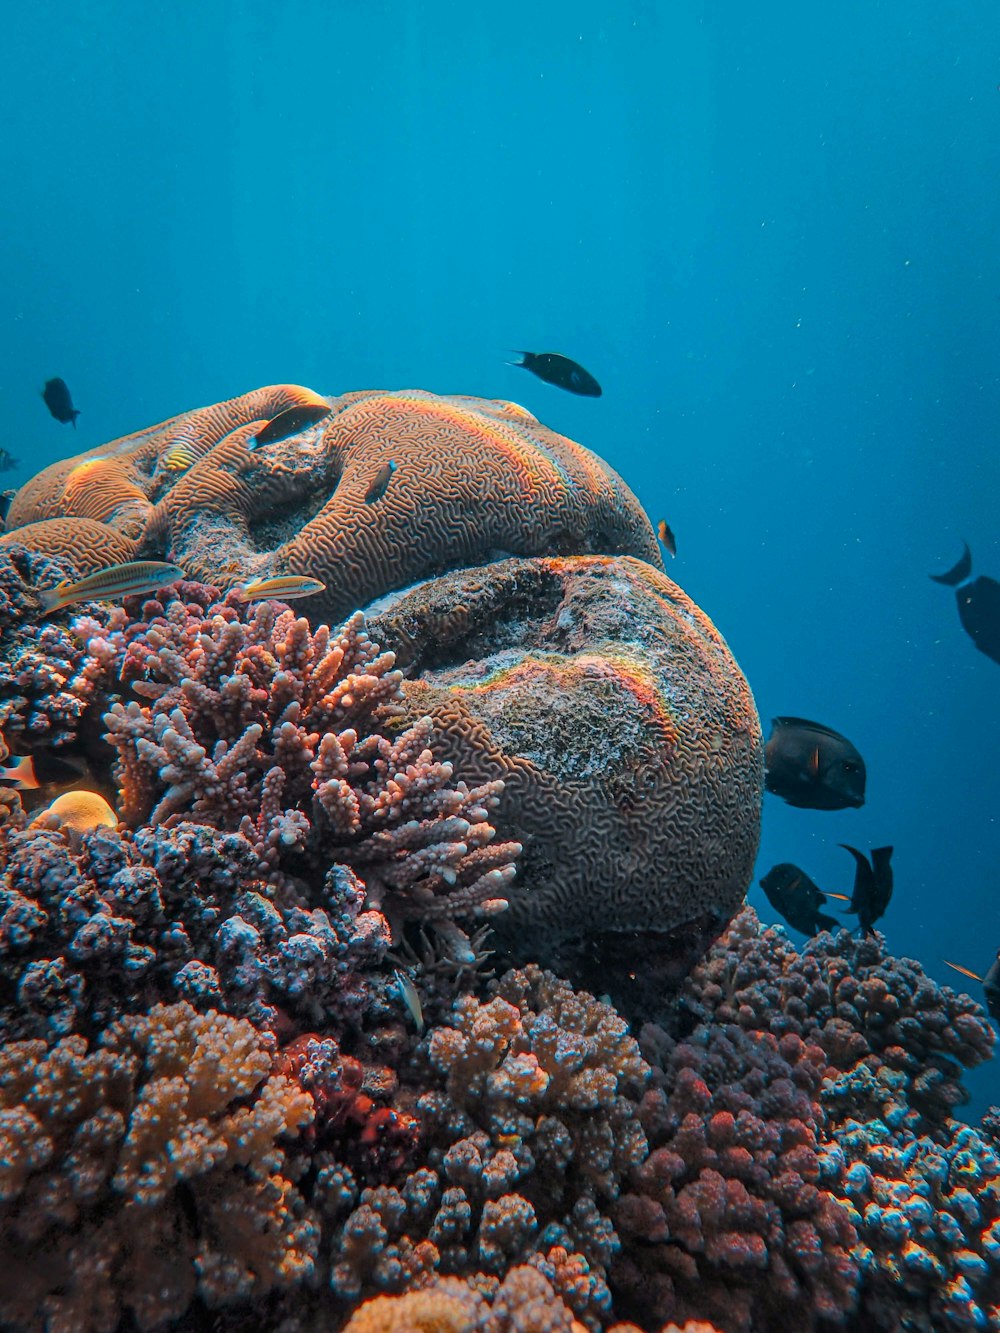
<box><xmin>764</xmin><ymin>717</ymin><xmax>868</xmax><ymax>810</ymax></box>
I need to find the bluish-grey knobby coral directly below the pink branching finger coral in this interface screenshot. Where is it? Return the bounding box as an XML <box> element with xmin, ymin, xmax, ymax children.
<box><xmin>0</xmin><ymin>822</ymin><xmax>389</xmax><ymax>1040</ymax></box>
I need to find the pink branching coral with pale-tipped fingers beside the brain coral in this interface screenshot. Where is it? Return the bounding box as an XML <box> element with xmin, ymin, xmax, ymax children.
<box><xmin>91</xmin><ymin>603</ymin><xmax>520</xmax><ymax>957</ymax></box>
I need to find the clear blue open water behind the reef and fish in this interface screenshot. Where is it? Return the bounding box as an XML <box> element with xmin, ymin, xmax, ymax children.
<box><xmin>0</xmin><ymin>0</ymin><xmax>1000</xmax><ymax>1104</ymax></box>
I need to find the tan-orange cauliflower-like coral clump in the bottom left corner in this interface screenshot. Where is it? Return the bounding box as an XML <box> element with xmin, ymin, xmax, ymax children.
<box><xmin>0</xmin><ymin>1004</ymin><xmax>316</xmax><ymax>1333</ymax></box>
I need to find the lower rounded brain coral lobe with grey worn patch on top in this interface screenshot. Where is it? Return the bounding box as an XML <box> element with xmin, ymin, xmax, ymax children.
<box><xmin>369</xmin><ymin>556</ymin><xmax>763</xmax><ymax>990</ymax></box>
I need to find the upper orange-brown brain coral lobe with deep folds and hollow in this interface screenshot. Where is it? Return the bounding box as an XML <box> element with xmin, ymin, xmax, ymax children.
<box><xmin>7</xmin><ymin>385</ymin><xmax>661</xmax><ymax>616</ymax></box>
